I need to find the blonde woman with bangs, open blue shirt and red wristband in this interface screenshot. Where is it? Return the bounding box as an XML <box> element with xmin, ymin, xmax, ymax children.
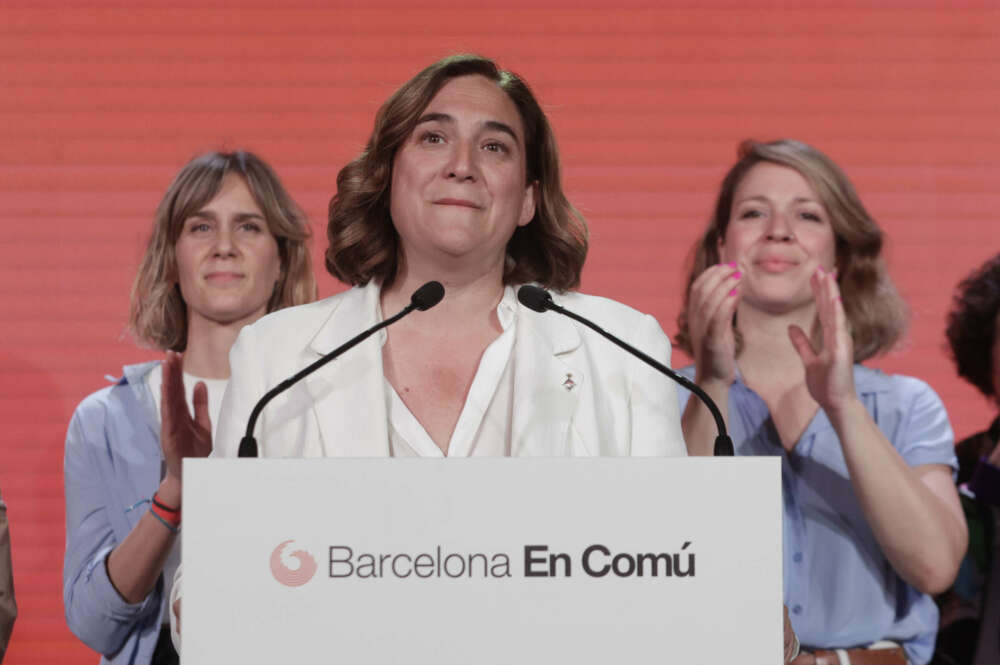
<box><xmin>63</xmin><ymin>151</ymin><xmax>316</xmax><ymax>665</ymax></box>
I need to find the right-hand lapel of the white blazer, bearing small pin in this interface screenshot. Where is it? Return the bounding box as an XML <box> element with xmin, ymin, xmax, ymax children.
<box><xmin>511</xmin><ymin>294</ymin><xmax>589</xmax><ymax>457</ymax></box>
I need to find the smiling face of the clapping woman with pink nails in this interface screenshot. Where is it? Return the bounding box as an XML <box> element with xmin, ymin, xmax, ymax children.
<box><xmin>719</xmin><ymin>162</ymin><xmax>837</xmax><ymax>313</ymax></box>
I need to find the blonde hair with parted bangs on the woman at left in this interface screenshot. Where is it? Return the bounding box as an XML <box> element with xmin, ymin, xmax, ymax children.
<box><xmin>129</xmin><ymin>150</ymin><xmax>316</xmax><ymax>351</ymax></box>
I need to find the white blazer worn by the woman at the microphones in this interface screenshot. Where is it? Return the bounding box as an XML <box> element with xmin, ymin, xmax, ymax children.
<box><xmin>213</xmin><ymin>284</ymin><xmax>686</xmax><ymax>457</ymax></box>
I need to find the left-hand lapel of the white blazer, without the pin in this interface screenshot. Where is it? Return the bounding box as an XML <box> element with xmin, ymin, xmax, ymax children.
<box><xmin>305</xmin><ymin>283</ymin><xmax>389</xmax><ymax>457</ymax></box>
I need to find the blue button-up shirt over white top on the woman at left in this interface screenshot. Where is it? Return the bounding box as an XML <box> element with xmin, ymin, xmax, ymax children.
<box><xmin>63</xmin><ymin>362</ymin><xmax>164</xmax><ymax>665</ymax></box>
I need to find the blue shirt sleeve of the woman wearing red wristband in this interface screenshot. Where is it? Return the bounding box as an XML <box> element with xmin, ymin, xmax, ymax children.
<box><xmin>63</xmin><ymin>396</ymin><xmax>163</xmax><ymax>654</ymax></box>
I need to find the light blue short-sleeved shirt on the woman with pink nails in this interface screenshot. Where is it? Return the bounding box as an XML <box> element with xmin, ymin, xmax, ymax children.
<box><xmin>678</xmin><ymin>365</ymin><xmax>958</xmax><ymax>665</ymax></box>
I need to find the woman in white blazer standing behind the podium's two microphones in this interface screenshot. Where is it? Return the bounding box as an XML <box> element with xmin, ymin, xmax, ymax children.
<box><xmin>203</xmin><ymin>56</ymin><xmax>685</xmax><ymax>457</ymax></box>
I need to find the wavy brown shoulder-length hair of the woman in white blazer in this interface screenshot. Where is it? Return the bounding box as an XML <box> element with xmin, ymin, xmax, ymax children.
<box><xmin>326</xmin><ymin>55</ymin><xmax>587</xmax><ymax>291</ymax></box>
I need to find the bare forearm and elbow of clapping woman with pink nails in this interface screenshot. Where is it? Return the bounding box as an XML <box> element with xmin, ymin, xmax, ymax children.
<box><xmin>827</xmin><ymin>400</ymin><xmax>968</xmax><ymax>593</ymax></box>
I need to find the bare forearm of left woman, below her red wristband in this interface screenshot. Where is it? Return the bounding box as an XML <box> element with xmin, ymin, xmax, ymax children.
<box><xmin>107</xmin><ymin>479</ymin><xmax>180</xmax><ymax>604</ymax></box>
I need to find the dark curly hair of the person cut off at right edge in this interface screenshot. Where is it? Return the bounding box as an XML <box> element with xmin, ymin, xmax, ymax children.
<box><xmin>947</xmin><ymin>254</ymin><xmax>1000</xmax><ymax>397</ymax></box>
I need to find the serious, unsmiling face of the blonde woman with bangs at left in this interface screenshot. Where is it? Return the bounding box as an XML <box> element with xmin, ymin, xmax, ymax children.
<box><xmin>175</xmin><ymin>173</ymin><xmax>281</xmax><ymax>335</ymax></box>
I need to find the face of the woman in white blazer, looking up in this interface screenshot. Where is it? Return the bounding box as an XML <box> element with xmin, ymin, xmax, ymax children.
<box><xmin>390</xmin><ymin>75</ymin><xmax>535</xmax><ymax>274</ymax></box>
